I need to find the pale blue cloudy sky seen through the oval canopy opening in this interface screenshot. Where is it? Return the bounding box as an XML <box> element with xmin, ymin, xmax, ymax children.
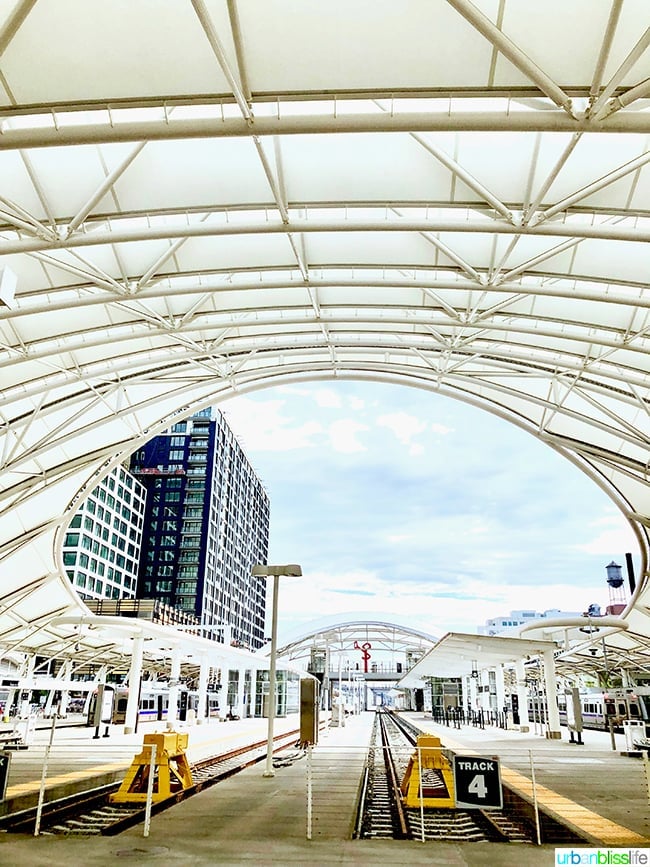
<box><xmin>221</xmin><ymin>382</ymin><xmax>637</xmax><ymax>637</ymax></box>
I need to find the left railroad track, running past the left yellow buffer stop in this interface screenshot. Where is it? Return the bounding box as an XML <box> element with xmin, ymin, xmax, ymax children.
<box><xmin>0</xmin><ymin>729</ymin><xmax>300</xmax><ymax>836</ymax></box>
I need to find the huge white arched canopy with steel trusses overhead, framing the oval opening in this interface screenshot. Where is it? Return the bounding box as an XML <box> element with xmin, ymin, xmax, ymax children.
<box><xmin>0</xmin><ymin>0</ymin><xmax>650</xmax><ymax>668</ymax></box>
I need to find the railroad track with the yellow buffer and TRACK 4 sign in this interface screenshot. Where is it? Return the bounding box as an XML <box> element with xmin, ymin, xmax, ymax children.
<box><xmin>356</xmin><ymin>712</ymin><xmax>533</xmax><ymax>843</ymax></box>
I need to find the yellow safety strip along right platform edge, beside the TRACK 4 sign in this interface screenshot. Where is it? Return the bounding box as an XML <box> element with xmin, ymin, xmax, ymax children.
<box><xmin>418</xmin><ymin>735</ymin><xmax>650</xmax><ymax>846</ymax></box>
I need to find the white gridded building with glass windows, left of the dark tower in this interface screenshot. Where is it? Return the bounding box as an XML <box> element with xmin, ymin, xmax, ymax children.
<box><xmin>63</xmin><ymin>466</ymin><xmax>146</xmax><ymax>599</ymax></box>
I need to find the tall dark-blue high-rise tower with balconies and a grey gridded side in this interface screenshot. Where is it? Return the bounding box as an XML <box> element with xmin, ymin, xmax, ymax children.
<box><xmin>131</xmin><ymin>409</ymin><xmax>269</xmax><ymax>649</ymax></box>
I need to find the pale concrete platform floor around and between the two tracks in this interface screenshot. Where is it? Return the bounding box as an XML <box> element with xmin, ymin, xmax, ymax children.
<box><xmin>0</xmin><ymin>713</ymin><xmax>650</xmax><ymax>867</ymax></box>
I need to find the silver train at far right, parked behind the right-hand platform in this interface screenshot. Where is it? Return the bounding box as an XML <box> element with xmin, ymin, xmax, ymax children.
<box><xmin>528</xmin><ymin>686</ymin><xmax>650</xmax><ymax>735</ymax></box>
